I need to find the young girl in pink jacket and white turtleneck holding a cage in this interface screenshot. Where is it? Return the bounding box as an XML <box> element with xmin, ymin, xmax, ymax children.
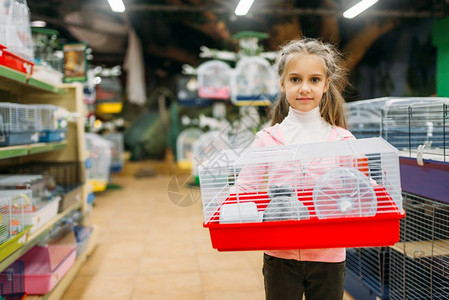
<box><xmin>248</xmin><ymin>38</ymin><xmax>354</xmax><ymax>300</ymax></box>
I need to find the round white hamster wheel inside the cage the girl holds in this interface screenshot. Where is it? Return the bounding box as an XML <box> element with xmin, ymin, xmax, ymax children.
<box><xmin>313</xmin><ymin>168</ymin><xmax>377</xmax><ymax>219</ymax></box>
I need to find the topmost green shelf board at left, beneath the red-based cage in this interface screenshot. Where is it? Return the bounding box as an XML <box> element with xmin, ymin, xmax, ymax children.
<box><xmin>0</xmin><ymin>66</ymin><xmax>66</xmax><ymax>95</ymax></box>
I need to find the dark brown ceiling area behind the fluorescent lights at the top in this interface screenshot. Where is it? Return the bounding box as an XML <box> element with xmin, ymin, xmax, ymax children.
<box><xmin>28</xmin><ymin>0</ymin><xmax>449</xmax><ymax>72</ymax></box>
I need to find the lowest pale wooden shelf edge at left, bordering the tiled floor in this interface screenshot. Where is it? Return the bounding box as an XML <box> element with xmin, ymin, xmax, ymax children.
<box><xmin>25</xmin><ymin>226</ymin><xmax>99</xmax><ymax>300</ymax></box>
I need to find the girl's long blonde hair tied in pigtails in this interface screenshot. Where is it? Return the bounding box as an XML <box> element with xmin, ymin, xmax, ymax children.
<box><xmin>271</xmin><ymin>38</ymin><xmax>348</xmax><ymax>128</ymax></box>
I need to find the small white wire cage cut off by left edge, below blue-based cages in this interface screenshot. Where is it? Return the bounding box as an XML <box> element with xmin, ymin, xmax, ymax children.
<box><xmin>0</xmin><ymin>190</ymin><xmax>25</xmax><ymax>244</ymax></box>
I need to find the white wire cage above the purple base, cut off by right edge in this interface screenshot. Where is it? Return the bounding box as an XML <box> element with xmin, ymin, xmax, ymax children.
<box><xmin>382</xmin><ymin>98</ymin><xmax>449</xmax><ymax>161</ymax></box>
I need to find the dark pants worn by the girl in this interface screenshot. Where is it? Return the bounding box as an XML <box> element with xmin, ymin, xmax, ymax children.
<box><xmin>263</xmin><ymin>254</ymin><xmax>346</xmax><ymax>300</ymax></box>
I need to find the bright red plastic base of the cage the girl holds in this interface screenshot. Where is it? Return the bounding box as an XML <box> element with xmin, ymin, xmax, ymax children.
<box><xmin>203</xmin><ymin>189</ymin><xmax>405</xmax><ymax>251</ymax></box>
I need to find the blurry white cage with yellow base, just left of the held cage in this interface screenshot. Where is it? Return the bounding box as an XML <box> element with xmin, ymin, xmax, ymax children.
<box><xmin>176</xmin><ymin>127</ymin><xmax>203</xmax><ymax>170</ymax></box>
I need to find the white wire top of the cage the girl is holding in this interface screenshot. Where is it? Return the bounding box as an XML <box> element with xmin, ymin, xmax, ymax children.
<box><xmin>199</xmin><ymin>138</ymin><xmax>402</xmax><ymax>223</ymax></box>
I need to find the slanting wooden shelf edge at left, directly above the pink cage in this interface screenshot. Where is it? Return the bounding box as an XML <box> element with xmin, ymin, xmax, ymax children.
<box><xmin>0</xmin><ymin>201</ymin><xmax>82</xmax><ymax>272</ymax></box>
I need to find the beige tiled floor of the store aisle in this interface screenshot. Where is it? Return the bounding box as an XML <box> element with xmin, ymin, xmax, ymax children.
<box><xmin>63</xmin><ymin>176</ymin><xmax>350</xmax><ymax>300</ymax></box>
